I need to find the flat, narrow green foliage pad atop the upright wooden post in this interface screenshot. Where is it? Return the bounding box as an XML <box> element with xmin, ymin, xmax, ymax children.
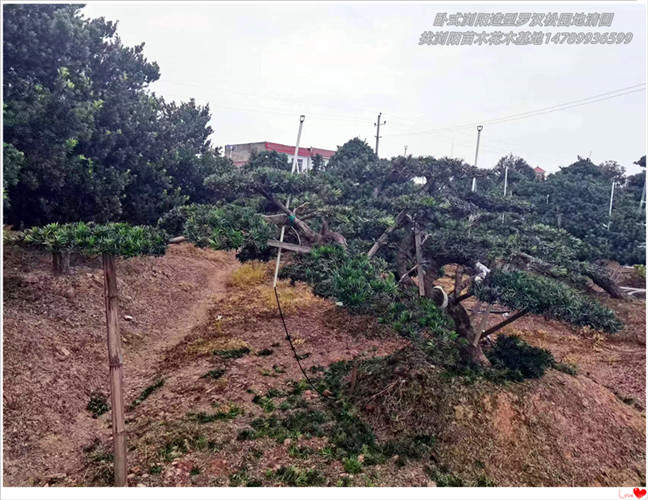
<box><xmin>23</xmin><ymin>222</ymin><xmax>167</xmax><ymax>257</ymax></box>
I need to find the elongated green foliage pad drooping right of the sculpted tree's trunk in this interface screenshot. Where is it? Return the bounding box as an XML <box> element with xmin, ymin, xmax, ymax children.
<box><xmin>473</xmin><ymin>270</ymin><xmax>623</xmax><ymax>333</ymax></box>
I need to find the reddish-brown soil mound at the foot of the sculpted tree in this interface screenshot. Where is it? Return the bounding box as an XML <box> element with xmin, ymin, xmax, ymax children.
<box><xmin>356</xmin><ymin>349</ymin><xmax>646</xmax><ymax>486</ymax></box>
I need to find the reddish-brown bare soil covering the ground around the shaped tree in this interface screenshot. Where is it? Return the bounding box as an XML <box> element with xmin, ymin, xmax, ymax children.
<box><xmin>3</xmin><ymin>245</ymin><xmax>645</xmax><ymax>486</ymax></box>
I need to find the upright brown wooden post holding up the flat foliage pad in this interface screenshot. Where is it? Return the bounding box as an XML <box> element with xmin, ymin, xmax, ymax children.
<box><xmin>102</xmin><ymin>254</ymin><xmax>128</xmax><ymax>486</ymax></box>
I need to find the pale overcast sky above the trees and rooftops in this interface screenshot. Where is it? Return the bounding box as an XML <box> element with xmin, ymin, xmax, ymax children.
<box><xmin>83</xmin><ymin>2</ymin><xmax>646</xmax><ymax>172</ymax></box>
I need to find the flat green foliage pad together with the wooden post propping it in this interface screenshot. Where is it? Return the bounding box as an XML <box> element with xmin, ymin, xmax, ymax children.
<box><xmin>24</xmin><ymin>223</ymin><xmax>167</xmax><ymax>486</ymax></box>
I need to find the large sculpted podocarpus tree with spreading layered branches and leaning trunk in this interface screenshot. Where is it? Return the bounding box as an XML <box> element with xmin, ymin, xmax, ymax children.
<box><xmin>207</xmin><ymin>139</ymin><xmax>621</xmax><ymax>365</ymax></box>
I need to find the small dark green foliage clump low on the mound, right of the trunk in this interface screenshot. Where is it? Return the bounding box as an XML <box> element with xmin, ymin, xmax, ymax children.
<box><xmin>485</xmin><ymin>335</ymin><xmax>555</xmax><ymax>382</ymax></box>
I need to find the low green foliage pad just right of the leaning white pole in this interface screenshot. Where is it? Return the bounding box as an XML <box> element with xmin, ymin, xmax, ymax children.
<box><xmin>281</xmin><ymin>246</ymin><xmax>397</xmax><ymax>312</ymax></box>
